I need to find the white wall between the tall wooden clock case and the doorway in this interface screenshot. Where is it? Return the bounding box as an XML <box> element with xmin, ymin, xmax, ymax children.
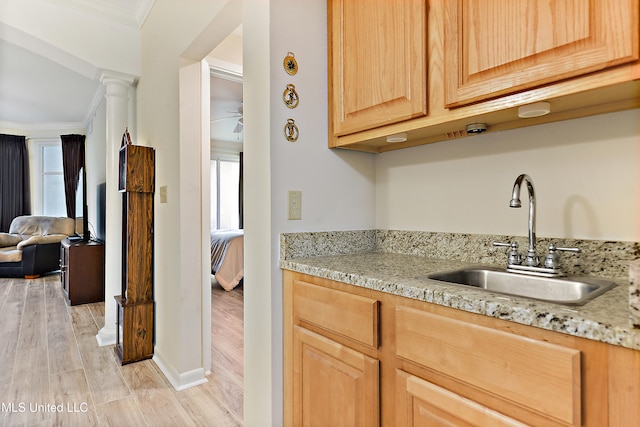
<box><xmin>136</xmin><ymin>0</ymin><xmax>232</xmax><ymax>387</ymax></box>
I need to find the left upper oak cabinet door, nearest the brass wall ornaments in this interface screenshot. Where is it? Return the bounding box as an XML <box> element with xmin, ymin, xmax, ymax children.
<box><xmin>328</xmin><ymin>0</ymin><xmax>427</xmax><ymax>136</ymax></box>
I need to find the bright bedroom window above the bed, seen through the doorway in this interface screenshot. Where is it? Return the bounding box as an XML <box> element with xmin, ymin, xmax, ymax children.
<box><xmin>211</xmin><ymin>156</ymin><xmax>240</xmax><ymax>230</ymax></box>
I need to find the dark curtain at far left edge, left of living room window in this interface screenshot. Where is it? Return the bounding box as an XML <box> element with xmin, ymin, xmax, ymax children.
<box><xmin>0</xmin><ymin>134</ymin><xmax>31</xmax><ymax>232</ymax></box>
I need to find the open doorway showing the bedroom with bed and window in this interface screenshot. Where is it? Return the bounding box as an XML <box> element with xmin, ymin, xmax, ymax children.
<box><xmin>205</xmin><ymin>30</ymin><xmax>244</xmax><ymax>425</ymax></box>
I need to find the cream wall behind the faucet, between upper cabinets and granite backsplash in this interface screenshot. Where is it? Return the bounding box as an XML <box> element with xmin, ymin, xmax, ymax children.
<box><xmin>376</xmin><ymin>110</ymin><xmax>640</xmax><ymax>241</ymax></box>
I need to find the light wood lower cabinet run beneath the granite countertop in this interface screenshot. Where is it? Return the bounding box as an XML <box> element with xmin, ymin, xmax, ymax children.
<box><xmin>283</xmin><ymin>270</ymin><xmax>640</xmax><ymax>427</ymax></box>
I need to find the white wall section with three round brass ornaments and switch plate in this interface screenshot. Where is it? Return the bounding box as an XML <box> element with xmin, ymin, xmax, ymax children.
<box><xmin>258</xmin><ymin>0</ymin><xmax>375</xmax><ymax>425</ymax></box>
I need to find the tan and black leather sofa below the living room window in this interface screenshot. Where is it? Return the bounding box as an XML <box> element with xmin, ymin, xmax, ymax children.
<box><xmin>0</xmin><ymin>215</ymin><xmax>75</xmax><ymax>279</ymax></box>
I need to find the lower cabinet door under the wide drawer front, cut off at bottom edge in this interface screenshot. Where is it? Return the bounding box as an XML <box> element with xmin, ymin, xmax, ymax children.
<box><xmin>396</xmin><ymin>370</ymin><xmax>526</xmax><ymax>427</ymax></box>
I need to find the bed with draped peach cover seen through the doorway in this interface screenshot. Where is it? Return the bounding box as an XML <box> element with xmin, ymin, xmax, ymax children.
<box><xmin>211</xmin><ymin>230</ymin><xmax>244</xmax><ymax>291</ymax></box>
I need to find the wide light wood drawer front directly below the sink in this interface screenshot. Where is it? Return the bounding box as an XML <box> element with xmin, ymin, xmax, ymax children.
<box><xmin>396</xmin><ymin>307</ymin><xmax>581</xmax><ymax>425</ymax></box>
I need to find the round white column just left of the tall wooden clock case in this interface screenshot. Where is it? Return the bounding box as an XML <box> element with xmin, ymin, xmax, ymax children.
<box><xmin>96</xmin><ymin>72</ymin><xmax>134</xmax><ymax>346</ymax></box>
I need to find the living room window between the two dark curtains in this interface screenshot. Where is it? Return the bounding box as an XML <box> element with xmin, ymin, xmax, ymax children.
<box><xmin>39</xmin><ymin>142</ymin><xmax>67</xmax><ymax>217</ymax></box>
